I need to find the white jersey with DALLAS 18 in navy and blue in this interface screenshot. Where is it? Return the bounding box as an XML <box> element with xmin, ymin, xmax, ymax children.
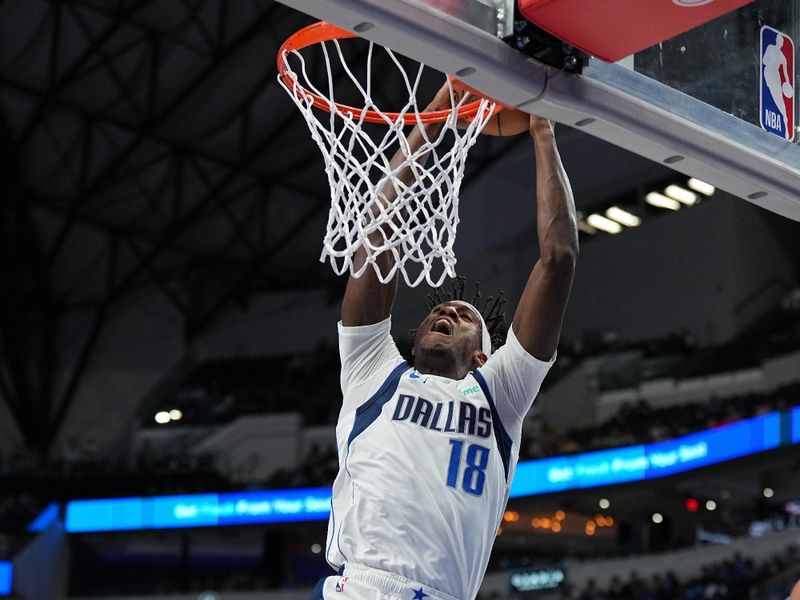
<box><xmin>326</xmin><ymin>319</ymin><xmax>555</xmax><ymax>600</ymax></box>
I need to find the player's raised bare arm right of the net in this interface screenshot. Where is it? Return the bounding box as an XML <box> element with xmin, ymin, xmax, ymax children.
<box><xmin>513</xmin><ymin>116</ymin><xmax>578</xmax><ymax>361</ymax></box>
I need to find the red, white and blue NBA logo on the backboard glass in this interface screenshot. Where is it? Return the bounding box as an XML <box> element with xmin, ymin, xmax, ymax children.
<box><xmin>759</xmin><ymin>25</ymin><xmax>795</xmax><ymax>141</ymax></box>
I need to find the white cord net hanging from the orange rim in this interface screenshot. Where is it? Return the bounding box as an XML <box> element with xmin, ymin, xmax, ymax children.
<box><xmin>278</xmin><ymin>32</ymin><xmax>495</xmax><ymax>287</ymax></box>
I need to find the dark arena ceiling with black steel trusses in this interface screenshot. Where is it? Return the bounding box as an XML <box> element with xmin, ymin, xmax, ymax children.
<box><xmin>0</xmin><ymin>0</ymin><xmax>692</xmax><ymax>452</ymax></box>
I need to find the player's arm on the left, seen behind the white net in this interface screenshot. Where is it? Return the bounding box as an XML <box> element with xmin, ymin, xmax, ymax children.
<box><xmin>342</xmin><ymin>84</ymin><xmax>450</xmax><ymax>327</ymax></box>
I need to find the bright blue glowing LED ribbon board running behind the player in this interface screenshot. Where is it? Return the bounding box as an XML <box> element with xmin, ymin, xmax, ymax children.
<box><xmin>64</xmin><ymin>407</ymin><xmax>800</xmax><ymax>532</ymax></box>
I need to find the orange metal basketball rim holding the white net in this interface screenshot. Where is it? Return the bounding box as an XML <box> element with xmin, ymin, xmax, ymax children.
<box><xmin>278</xmin><ymin>21</ymin><xmax>502</xmax><ymax>125</ymax></box>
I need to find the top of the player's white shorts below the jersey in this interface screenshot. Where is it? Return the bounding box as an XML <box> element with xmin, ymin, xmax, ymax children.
<box><xmin>311</xmin><ymin>563</ymin><xmax>458</xmax><ymax>600</ymax></box>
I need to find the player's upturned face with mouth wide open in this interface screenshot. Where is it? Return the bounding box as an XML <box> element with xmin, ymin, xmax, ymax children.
<box><xmin>414</xmin><ymin>302</ymin><xmax>481</xmax><ymax>356</ymax></box>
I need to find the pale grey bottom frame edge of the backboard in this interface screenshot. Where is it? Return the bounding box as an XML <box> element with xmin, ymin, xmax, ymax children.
<box><xmin>279</xmin><ymin>0</ymin><xmax>800</xmax><ymax>221</ymax></box>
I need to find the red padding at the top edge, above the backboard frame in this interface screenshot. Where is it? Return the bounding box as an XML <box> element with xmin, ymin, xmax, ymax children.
<box><xmin>519</xmin><ymin>0</ymin><xmax>753</xmax><ymax>62</ymax></box>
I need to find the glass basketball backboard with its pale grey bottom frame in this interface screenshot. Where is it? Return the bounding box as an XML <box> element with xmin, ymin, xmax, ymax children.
<box><xmin>280</xmin><ymin>0</ymin><xmax>800</xmax><ymax>221</ymax></box>
